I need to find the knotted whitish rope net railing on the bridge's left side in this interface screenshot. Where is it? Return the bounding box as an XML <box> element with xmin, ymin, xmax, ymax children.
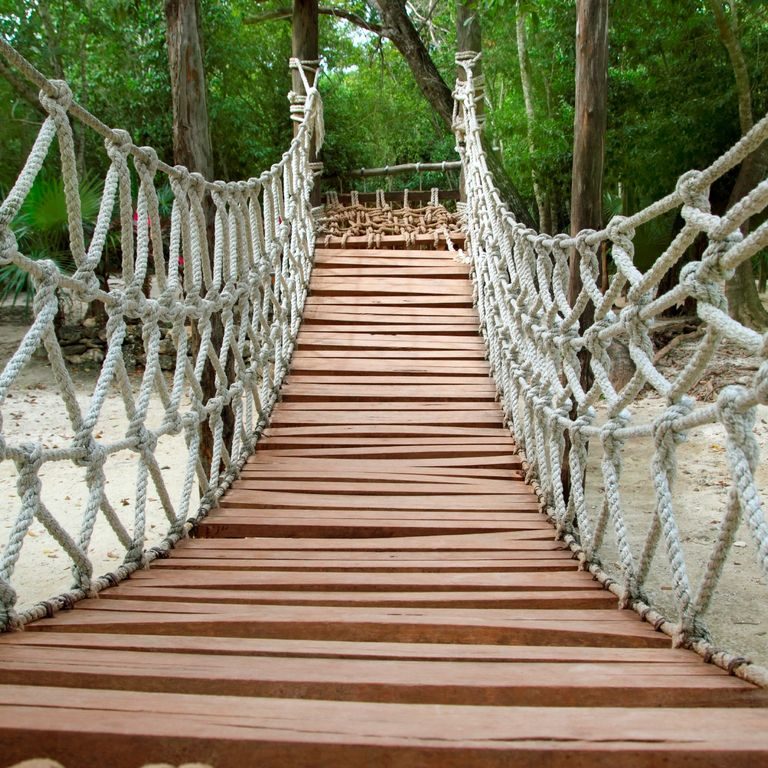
<box><xmin>0</xmin><ymin>41</ymin><xmax>323</xmax><ymax>630</ymax></box>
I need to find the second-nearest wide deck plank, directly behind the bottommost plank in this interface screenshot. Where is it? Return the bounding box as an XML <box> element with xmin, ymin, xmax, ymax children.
<box><xmin>0</xmin><ymin>647</ymin><xmax>768</xmax><ymax>707</ymax></box>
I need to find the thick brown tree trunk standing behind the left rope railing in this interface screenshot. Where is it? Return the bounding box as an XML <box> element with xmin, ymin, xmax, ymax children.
<box><xmin>165</xmin><ymin>0</ymin><xmax>234</xmax><ymax>486</ymax></box>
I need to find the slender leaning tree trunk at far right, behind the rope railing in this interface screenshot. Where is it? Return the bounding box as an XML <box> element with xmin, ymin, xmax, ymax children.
<box><xmin>709</xmin><ymin>0</ymin><xmax>768</xmax><ymax>330</ymax></box>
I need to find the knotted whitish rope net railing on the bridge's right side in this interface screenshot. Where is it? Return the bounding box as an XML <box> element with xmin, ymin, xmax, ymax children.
<box><xmin>454</xmin><ymin>53</ymin><xmax>768</xmax><ymax>685</ymax></box>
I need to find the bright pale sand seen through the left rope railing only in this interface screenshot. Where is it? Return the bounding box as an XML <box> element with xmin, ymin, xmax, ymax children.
<box><xmin>0</xmin><ymin>307</ymin><xmax>198</xmax><ymax>609</ymax></box>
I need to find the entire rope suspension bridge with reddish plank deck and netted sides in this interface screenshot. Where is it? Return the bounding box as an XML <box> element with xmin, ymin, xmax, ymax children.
<box><xmin>0</xmin><ymin>46</ymin><xmax>768</xmax><ymax>768</ymax></box>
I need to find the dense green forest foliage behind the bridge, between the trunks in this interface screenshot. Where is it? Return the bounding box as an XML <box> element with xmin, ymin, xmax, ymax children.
<box><xmin>0</xmin><ymin>0</ymin><xmax>768</xmax><ymax>317</ymax></box>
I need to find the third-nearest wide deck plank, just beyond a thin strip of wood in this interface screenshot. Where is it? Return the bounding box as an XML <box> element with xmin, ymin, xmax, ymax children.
<box><xmin>25</xmin><ymin>608</ymin><xmax>669</xmax><ymax>647</ymax></box>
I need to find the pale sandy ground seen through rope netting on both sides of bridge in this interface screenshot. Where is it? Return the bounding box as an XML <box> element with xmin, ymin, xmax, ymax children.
<box><xmin>0</xmin><ymin>308</ymin><xmax>768</xmax><ymax>666</ymax></box>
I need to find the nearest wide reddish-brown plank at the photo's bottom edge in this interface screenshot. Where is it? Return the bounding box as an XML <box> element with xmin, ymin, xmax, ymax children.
<box><xmin>9</xmin><ymin>685</ymin><xmax>768</xmax><ymax>768</ymax></box>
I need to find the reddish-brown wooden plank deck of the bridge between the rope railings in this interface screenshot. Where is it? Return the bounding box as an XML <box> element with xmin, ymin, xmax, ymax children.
<box><xmin>0</xmin><ymin>249</ymin><xmax>768</xmax><ymax>768</ymax></box>
